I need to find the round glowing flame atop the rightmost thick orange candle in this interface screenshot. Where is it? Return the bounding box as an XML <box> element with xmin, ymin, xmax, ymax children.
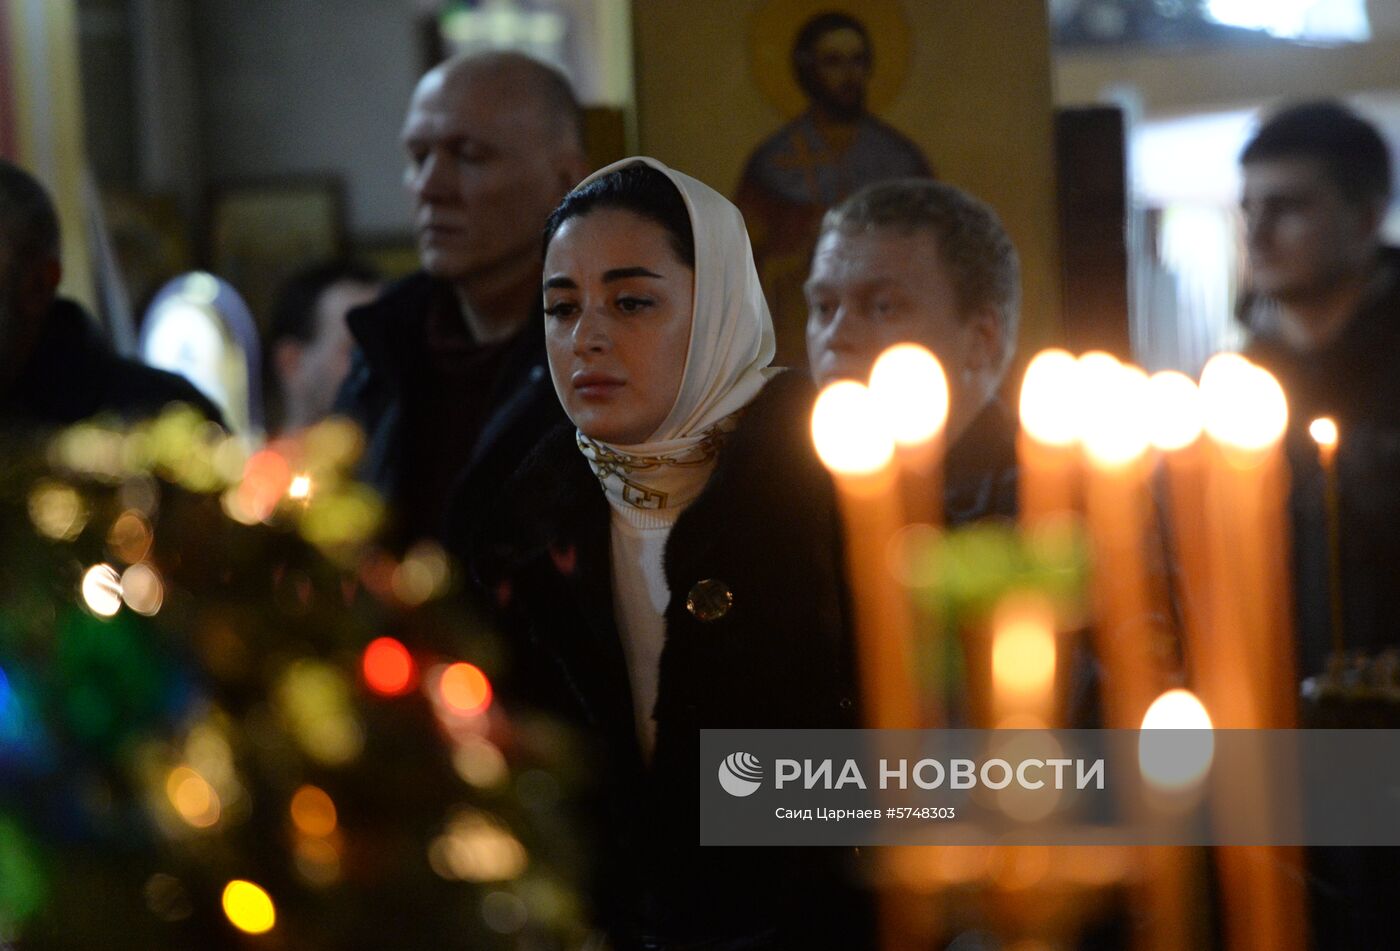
<box><xmin>1201</xmin><ymin>353</ymin><xmax>1288</xmax><ymax>451</ymax></box>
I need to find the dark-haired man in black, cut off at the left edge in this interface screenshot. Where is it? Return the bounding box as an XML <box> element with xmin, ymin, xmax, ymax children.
<box><xmin>0</xmin><ymin>160</ymin><xmax>221</xmax><ymax>429</ymax></box>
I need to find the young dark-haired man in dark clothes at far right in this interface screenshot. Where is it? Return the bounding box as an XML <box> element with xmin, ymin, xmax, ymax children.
<box><xmin>1240</xmin><ymin>102</ymin><xmax>1400</xmax><ymax>951</ymax></box>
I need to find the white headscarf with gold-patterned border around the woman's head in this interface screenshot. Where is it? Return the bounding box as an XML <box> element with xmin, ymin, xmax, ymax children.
<box><xmin>557</xmin><ymin>155</ymin><xmax>776</xmax><ymax>510</ymax></box>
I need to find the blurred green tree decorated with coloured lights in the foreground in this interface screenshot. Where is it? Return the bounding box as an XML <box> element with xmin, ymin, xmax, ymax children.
<box><xmin>0</xmin><ymin>410</ymin><xmax>587</xmax><ymax>951</ymax></box>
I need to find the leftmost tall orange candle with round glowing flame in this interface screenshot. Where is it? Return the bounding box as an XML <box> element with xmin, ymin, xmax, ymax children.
<box><xmin>812</xmin><ymin>380</ymin><xmax>920</xmax><ymax>730</ymax></box>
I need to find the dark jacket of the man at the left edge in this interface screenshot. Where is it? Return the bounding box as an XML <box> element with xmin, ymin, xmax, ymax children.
<box><xmin>0</xmin><ymin>297</ymin><xmax>223</xmax><ymax>429</ymax></box>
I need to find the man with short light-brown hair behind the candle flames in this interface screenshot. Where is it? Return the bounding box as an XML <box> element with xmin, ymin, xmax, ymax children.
<box><xmin>805</xmin><ymin>178</ymin><xmax>1021</xmax><ymax>525</ymax></box>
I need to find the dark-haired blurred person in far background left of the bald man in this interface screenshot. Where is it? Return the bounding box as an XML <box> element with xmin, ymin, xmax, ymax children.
<box><xmin>267</xmin><ymin>261</ymin><xmax>381</xmax><ymax>431</ymax></box>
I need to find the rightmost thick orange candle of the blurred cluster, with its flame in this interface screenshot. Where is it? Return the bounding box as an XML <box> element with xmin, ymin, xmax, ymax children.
<box><xmin>1191</xmin><ymin>354</ymin><xmax>1308</xmax><ymax>951</ymax></box>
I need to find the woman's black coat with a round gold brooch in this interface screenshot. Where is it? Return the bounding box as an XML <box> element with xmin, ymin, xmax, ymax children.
<box><xmin>477</xmin><ymin>373</ymin><xmax>869</xmax><ymax>948</ymax></box>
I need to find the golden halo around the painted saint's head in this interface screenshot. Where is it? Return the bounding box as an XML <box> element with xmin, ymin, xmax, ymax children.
<box><xmin>749</xmin><ymin>0</ymin><xmax>910</xmax><ymax>119</ymax></box>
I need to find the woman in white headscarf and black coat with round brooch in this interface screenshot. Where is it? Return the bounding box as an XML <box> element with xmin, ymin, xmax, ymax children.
<box><xmin>479</xmin><ymin>158</ymin><xmax>868</xmax><ymax>951</ymax></box>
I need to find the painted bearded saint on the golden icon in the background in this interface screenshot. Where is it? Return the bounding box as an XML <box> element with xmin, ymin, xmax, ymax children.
<box><xmin>735</xmin><ymin>3</ymin><xmax>932</xmax><ymax>367</ymax></box>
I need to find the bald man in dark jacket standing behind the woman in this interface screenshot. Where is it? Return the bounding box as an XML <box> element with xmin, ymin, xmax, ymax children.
<box><xmin>337</xmin><ymin>53</ymin><xmax>588</xmax><ymax>550</ymax></box>
